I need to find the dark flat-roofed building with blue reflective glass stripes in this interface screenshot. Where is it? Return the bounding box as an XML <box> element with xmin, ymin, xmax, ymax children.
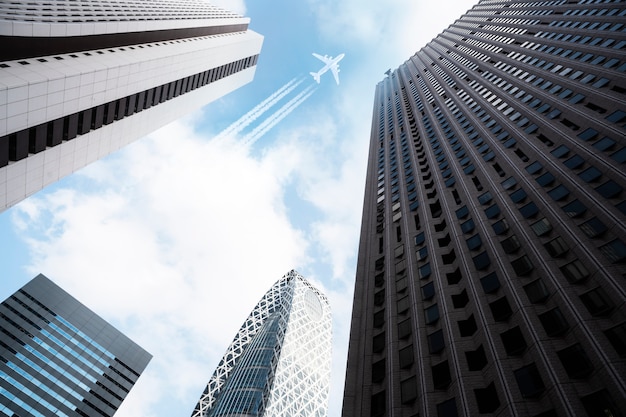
<box><xmin>0</xmin><ymin>275</ymin><xmax>152</xmax><ymax>417</ymax></box>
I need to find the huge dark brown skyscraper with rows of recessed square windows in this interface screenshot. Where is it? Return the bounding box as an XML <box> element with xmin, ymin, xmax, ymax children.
<box><xmin>343</xmin><ymin>0</ymin><xmax>626</xmax><ymax>417</ymax></box>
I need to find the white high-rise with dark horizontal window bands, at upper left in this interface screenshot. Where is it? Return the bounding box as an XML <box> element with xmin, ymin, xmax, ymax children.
<box><xmin>0</xmin><ymin>0</ymin><xmax>263</xmax><ymax>211</ymax></box>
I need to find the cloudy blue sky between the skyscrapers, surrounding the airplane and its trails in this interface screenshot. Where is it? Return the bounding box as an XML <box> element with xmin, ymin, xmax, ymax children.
<box><xmin>0</xmin><ymin>0</ymin><xmax>473</xmax><ymax>417</ymax></box>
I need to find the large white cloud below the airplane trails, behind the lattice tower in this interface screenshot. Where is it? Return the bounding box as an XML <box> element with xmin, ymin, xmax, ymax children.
<box><xmin>15</xmin><ymin>115</ymin><xmax>308</xmax><ymax>417</ymax></box>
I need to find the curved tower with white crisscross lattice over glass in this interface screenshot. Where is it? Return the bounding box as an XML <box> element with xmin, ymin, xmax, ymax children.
<box><xmin>192</xmin><ymin>270</ymin><xmax>332</xmax><ymax>417</ymax></box>
